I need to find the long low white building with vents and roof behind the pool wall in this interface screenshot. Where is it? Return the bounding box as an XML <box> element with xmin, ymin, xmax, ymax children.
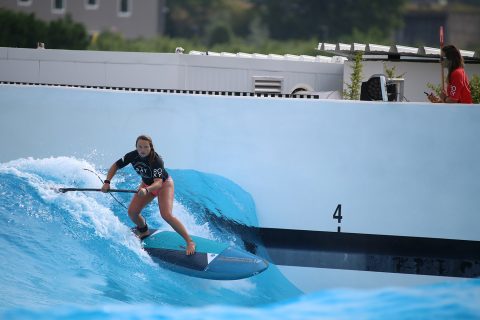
<box><xmin>0</xmin><ymin>43</ymin><xmax>480</xmax><ymax>102</ymax></box>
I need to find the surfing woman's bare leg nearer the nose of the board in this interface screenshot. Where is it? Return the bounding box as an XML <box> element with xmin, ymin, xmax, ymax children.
<box><xmin>158</xmin><ymin>178</ymin><xmax>195</xmax><ymax>255</ymax></box>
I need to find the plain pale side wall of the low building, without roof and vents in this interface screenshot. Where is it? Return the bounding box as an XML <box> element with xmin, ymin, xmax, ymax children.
<box><xmin>0</xmin><ymin>47</ymin><xmax>343</xmax><ymax>94</ymax></box>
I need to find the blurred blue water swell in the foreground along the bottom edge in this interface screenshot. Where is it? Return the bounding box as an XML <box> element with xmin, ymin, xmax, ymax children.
<box><xmin>0</xmin><ymin>279</ymin><xmax>480</xmax><ymax>320</ymax></box>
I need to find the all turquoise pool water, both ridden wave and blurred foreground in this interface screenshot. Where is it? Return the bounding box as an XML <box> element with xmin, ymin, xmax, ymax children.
<box><xmin>0</xmin><ymin>157</ymin><xmax>480</xmax><ymax>320</ymax></box>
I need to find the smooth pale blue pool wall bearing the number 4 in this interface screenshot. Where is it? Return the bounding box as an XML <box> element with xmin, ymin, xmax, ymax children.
<box><xmin>0</xmin><ymin>85</ymin><xmax>480</xmax><ymax>240</ymax></box>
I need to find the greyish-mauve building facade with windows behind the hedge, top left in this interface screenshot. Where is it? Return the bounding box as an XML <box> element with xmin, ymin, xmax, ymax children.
<box><xmin>0</xmin><ymin>0</ymin><xmax>166</xmax><ymax>39</ymax></box>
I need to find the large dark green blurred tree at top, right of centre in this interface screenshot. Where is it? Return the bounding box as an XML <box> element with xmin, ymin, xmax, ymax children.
<box><xmin>255</xmin><ymin>0</ymin><xmax>406</xmax><ymax>42</ymax></box>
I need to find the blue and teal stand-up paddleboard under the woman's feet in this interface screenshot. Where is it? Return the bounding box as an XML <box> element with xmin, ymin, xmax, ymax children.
<box><xmin>142</xmin><ymin>229</ymin><xmax>268</xmax><ymax>280</ymax></box>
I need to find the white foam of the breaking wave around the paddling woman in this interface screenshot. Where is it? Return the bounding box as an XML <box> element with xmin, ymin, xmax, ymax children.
<box><xmin>0</xmin><ymin>157</ymin><xmax>217</xmax><ymax>262</ymax></box>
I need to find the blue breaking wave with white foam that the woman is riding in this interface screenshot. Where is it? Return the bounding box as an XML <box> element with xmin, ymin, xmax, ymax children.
<box><xmin>0</xmin><ymin>157</ymin><xmax>300</xmax><ymax>309</ymax></box>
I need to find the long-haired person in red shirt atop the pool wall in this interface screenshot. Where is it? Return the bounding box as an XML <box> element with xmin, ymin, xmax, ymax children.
<box><xmin>428</xmin><ymin>45</ymin><xmax>472</xmax><ymax>103</ymax></box>
